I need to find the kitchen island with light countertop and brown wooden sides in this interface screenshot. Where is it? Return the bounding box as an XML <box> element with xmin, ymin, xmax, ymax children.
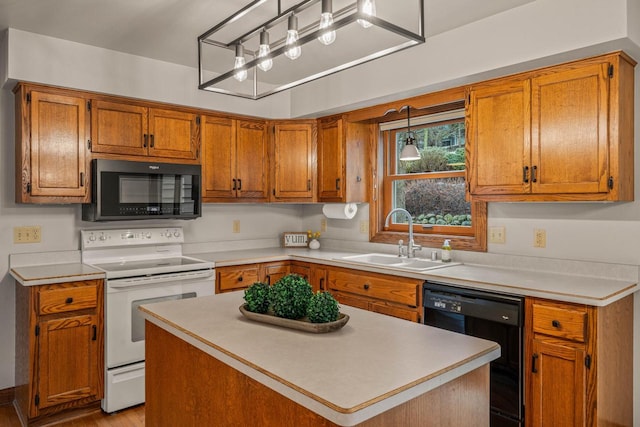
<box><xmin>141</xmin><ymin>292</ymin><xmax>500</xmax><ymax>426</ymax></box>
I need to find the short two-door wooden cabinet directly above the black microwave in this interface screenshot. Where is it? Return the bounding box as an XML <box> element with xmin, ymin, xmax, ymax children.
<box><xmin>91</xmin><ymin>99</ymin><xmax>200</xmax><ymax>160</ymax></box>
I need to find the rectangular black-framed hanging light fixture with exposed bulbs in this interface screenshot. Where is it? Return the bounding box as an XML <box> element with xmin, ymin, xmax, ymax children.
<box><xmin>198</xmin><ymin>0</ymin><xmax>425</xmax><ymax>99</ymax></box>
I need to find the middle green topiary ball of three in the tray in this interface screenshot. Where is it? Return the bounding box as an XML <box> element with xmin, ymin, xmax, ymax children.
<box><xmin>270</xmin><ymin>274</ymin><xmax>313</xmax><ymax>319</ymax></box>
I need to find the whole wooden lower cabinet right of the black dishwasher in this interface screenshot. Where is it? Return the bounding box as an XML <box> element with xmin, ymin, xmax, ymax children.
<box><xmin>525</xmin><ymin>295</ymin><xmax>633</xmax><ymax>427</ymax></box>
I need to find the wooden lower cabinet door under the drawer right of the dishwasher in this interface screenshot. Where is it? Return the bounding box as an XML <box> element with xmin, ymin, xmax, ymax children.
<box><xmin>527</xmin><ymin>339</ymin><xmax>587</xmax><ymax>427</ymax></box>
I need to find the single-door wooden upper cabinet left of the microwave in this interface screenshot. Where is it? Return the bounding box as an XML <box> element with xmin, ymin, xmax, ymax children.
<box><xmin>15</xmin><ymin>84</ymin><xmax>89</xmax><ymax>203</ymax></box>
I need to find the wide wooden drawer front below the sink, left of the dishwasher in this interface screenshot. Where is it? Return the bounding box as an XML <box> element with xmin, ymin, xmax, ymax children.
<box><xmin>329</xmin><ymin>270</ymin><xmax>420</xmax><ymax>307</ymax></box>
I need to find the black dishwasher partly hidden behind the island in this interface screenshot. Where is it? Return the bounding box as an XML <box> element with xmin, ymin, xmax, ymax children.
<box><xmin>423</xmin><ymin>281</ymin><xmax>524</xmax><ymax>427</ymax></box>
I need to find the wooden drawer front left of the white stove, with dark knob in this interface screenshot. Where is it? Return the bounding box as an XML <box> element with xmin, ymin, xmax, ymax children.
<box><xmin>38</xmin><ymin>281</ymin><xmax>98</xmax><ymax>315</ymax></box>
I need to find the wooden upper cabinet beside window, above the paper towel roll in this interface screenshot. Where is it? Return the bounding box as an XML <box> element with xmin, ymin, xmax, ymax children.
<box><xmin>318</xmin><ymin>117</ymin><xmax>369</xmax><ymax>203</ymax></box>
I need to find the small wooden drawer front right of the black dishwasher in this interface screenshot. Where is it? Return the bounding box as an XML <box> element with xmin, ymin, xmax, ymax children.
<box><xmin>533</xmin><ymin>303</ymin><xmax>588</xmax><ymax>342</ymax></box>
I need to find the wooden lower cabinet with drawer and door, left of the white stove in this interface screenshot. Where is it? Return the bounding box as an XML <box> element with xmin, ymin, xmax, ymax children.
<box><xmin>15</xmin><ymin>280</ymin><xmax>104</xmax><ymax>424</ymax></box>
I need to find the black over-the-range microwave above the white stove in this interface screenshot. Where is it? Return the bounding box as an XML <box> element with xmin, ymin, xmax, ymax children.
<box><xmin>82</xmin><ymin>159</ymin><xmax>202</xmax><ymax>221</ymax></box>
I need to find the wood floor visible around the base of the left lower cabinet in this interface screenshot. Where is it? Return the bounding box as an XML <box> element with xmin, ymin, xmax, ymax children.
<box><xmin>0</xmin><ymin>405</ymin><xmax>144</xmax><ymax>427</ymax></box>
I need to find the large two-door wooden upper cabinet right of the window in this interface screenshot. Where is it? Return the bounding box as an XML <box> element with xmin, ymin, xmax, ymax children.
<box><xmin>467</xmin><ymin>53</ymin><xmax>635</xmax><ymax>201</ymax></box>
